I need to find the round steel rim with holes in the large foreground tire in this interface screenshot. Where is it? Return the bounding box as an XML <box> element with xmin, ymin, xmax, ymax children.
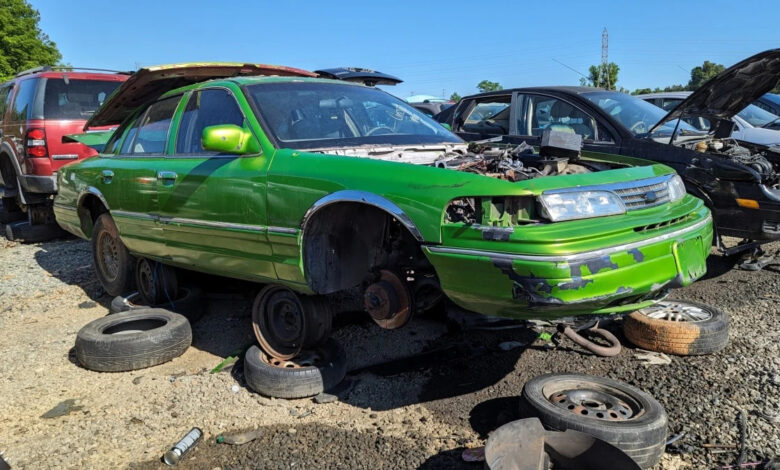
<box><xmin>549</xmin><ymin>389</ymin><xmax>635</xmax><ymax>421</ymax></box>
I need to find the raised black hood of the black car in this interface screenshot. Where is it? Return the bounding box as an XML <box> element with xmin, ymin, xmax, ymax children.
<box><xmin>650</xmin><ymin>49</ymin><xmax>780</xmax><ymax>133</ymax></box>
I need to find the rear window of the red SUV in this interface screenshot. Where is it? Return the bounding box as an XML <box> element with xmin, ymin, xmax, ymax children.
<box><xmin>43</xmin><ymin>78</ymin><xmax>122</xmax><ymax>119</ymax></box>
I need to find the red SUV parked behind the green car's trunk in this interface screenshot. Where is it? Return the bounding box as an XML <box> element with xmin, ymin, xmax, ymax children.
<box><xmin>0</xmin><ymin>67</ymin><xmax>129</xmax><ymax>234</ymax></box>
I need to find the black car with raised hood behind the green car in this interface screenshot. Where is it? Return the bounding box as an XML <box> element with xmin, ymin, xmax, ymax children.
<box><xmin>436</xmin><ymin>49</ymin><xmax>780</xmax><ymax>269</ymax></box>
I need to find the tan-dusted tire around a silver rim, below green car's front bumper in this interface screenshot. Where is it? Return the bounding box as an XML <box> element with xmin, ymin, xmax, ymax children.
<box><xmin>623</xmin><ymin>301</ymin><xmax>729</xmax><ymax>356</ymax></box>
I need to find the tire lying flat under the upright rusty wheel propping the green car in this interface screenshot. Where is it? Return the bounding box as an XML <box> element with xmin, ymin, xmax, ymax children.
<box><xmin>244</xmin><ymin>338</ymin><xmax>347</xmax><ymax>398</ymax></box>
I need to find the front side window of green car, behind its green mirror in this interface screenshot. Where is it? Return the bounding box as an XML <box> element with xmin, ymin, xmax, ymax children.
<box><xmin>176</xmin><ymin>88</ymin><xmax>244</xmax><ymax>155</ymax></box>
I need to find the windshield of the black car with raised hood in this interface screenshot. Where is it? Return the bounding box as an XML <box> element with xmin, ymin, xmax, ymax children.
<box><xmin>583</xmin><ymin>91</ymin><xmax>701</xmax><ymax>137</ymax></box>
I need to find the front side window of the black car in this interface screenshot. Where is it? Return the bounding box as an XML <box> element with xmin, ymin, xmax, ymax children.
<box><xmin>518</xmin><ymin>95</ymin><xmax>596</xmax><ymax>139</ymax></box>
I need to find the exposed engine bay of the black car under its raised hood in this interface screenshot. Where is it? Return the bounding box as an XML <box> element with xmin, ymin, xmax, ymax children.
<box><xmin>680</xmin><ymin>138</ymin><xmax>780</xmax><ymax>189</ymax></box>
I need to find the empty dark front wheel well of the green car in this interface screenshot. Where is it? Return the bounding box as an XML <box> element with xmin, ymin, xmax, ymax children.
<box><xmin>303</xmin><ymin>202</ymin><xmax>427</xmax><ymax>294</ymax></box>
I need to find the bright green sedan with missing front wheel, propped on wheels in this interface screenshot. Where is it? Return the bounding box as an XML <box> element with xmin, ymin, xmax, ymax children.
<box><xmin>54</xmin><ymin>64</ymin><xmax>713</xmax><ymax>357</ymax></box>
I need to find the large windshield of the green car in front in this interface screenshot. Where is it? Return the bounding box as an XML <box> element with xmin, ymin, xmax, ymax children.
<box><xmin>247</xmin><ymin>82</ymin><xmax>463</xmax><ymax>149</ymax></box>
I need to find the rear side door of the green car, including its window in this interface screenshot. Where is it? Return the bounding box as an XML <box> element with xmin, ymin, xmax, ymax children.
<box><xmin>104</xmin><ymin>95</ymin><xmax>181</xmax><ymax>258</ymax></box>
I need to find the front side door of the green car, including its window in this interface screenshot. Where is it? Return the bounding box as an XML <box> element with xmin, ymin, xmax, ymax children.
<box><xmin>158</xmin><ymin>87</ymin><xmax>276</xmax><ymax>279</ymax></box>
